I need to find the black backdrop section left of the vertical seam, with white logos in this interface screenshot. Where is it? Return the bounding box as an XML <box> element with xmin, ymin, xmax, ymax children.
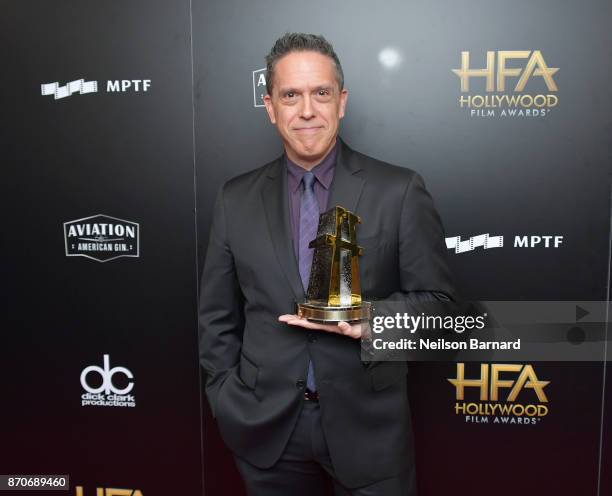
<box><xmin>0</xmin><ymin>0</ymin><xmax>202</xmax><ymax>496</ymax></box>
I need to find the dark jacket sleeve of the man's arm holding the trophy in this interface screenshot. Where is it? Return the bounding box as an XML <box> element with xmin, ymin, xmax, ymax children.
<box><xmin>362</xmin><ymin>173</ymin><xmax>456</xmax><ymax>365</ymax></box>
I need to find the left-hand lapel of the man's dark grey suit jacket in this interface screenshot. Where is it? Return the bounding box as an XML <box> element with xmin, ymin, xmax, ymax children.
<box><xmin>261</xmin><ymin>157</ymin><xmax>305</xmax><ymax>300</ymax></box>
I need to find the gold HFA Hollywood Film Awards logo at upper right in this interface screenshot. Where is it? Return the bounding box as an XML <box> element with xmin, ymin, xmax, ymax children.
<box><xmin>452</xmin><ymin>50</ymin><xmax>559</xmax><ymax>117</ymax></box>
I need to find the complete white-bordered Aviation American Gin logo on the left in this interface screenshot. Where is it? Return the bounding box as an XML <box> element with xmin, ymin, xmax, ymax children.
<box><xmin>64</xmin><ymin>214</ymin><xmax>140</xmax><ymax>262</ymax></box>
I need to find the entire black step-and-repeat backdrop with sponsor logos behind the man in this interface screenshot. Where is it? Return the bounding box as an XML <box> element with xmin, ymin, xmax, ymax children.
<box><xmin>0</xmin><ymin>0</ymin><xmax>612</xmax><ymax>496</ymax></box>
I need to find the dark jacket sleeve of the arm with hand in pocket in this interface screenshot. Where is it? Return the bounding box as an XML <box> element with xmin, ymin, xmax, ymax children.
<box><xmin>199</xmin><ymin>187</ymin><xmax>244</xmax><ymax>416</ymax></box>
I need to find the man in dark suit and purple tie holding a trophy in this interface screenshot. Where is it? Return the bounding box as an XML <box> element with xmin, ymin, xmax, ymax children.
<box><xmin>200</xmin><ymin>33</ymin><xmax>453</xmax><ymax>496</ymax></box>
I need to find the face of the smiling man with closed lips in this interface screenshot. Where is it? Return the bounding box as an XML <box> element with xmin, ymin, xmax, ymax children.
<box><xmin>264</xmin><ymin>52</ymin><xmax>348</xmax><ymax>169</ymax></box>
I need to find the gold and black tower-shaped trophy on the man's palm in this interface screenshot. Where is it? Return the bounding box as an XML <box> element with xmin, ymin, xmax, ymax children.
<box><xmin>298</xmin><ymin>206</ymin><xmax>372</xmax><ymax>324</ymax></box>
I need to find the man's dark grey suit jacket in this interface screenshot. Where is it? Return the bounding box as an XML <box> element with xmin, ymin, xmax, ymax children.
<box><xmin>200</xmin><ymin>140</ymin><xmax>453</xmax><ymax>487</ymax></box>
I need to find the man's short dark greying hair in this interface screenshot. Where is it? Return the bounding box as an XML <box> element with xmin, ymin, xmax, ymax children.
<box><xmin>266</xmin><ymin>33</ymin><xmax>344</xmax><ymax>95</ymax></box>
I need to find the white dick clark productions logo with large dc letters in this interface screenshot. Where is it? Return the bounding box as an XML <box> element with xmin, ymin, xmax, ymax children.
<box><xmin>80</xmin><ymin>355</ymin><xmax>136</xmax><ymax>407</ymax></box>
